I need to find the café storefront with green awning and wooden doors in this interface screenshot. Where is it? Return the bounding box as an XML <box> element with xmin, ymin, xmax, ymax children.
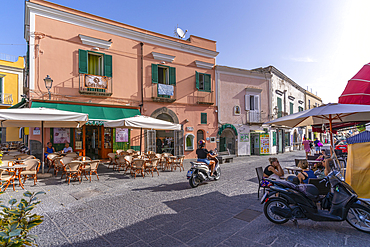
<box><xmin>31</xmin><ymin>101</ymin><xmax>140</xmax><ymax>159</ymax></box>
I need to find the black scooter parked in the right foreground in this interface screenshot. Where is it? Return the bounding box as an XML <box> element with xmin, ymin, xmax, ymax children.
<box><xmin>261</xmin><ymin>171</ymin><xmax>370</xmax><ymax>233</ymax></box>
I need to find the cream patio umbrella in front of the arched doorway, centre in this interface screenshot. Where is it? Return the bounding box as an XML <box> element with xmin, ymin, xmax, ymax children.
<box><xmin>104</xmin><ymin>115</ymin><xmax>181</xmax><ymax>153</ymax></box>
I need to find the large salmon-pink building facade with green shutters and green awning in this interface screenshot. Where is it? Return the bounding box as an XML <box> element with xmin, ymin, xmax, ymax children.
<box><xmin>25</xmin><ymin>0</ymin><xmax>218</xmax><ymax>158</ymax></box>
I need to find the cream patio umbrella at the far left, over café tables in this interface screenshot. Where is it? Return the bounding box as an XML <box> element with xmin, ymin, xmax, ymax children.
<box><xmin>0</xmin><ymin>108</ymin><xmax>89</xmax><ymax>173</ymax></box>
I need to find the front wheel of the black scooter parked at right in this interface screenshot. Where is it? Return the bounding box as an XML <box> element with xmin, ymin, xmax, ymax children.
<box><xmin>346</xmin><ymin>203</ymin><xmax>370</xmax><ymax>233</ymax></box>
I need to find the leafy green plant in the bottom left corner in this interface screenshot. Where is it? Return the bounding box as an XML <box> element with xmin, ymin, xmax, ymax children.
<box><xmin>0</xmin><ymin>191</ymin><xmax>45</xmax><ymax>247</ymax></box>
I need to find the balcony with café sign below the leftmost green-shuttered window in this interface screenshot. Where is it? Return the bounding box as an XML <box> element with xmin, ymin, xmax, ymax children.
<box><xmin>79</xmin><ymin>74</ymin><xmax>113</xmax><ymax>96</ymax></box>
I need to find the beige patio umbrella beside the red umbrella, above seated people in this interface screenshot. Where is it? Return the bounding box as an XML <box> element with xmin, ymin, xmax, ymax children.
<box><xmin>265</xmin><ymin>103</ymin><xmax>370</xmax><ymax>146</ymax></box>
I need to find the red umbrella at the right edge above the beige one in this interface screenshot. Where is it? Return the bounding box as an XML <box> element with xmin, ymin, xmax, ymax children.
<box><xmin>338</xmin><ymin>63</ymin><xmax>370</xmax><ymax>105</ymax></box>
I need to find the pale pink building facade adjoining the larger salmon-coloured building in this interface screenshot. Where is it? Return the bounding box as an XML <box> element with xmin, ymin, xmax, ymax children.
<box><xmin>215</xmin><ymin>66</ymin><xmax>271</xmax><ymax>156</ymax></box>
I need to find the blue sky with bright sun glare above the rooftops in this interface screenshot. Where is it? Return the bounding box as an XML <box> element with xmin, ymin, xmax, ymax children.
<box><xmin>0</xmin><ymin>0</ymin><xmax>370</xmax><ymax>103</ymax></box>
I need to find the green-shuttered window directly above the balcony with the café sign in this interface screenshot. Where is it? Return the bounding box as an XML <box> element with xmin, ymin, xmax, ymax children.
<box><xmin>78</xmin><ymin>49</ymin><xmax>112</xmax><ymax>77</ymax></box>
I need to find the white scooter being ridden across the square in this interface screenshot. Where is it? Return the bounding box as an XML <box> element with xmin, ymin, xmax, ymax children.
<box><xmin>186</xmin><ymin>151</ymin><xmax>221</xmax><ymax>188</ymax></box>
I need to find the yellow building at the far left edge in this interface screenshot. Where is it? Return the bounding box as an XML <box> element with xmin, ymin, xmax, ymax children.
<box><xmin>0</xmin><ymin>54</ymin><xmax>24</xmax><ymax>142</ymax></box>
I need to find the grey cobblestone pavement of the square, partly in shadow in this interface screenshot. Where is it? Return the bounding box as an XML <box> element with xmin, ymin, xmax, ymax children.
<box><xmin>2</xmin><ymin>151</ymin><xmax>370</xmax><ymax>247</ymax></box>
